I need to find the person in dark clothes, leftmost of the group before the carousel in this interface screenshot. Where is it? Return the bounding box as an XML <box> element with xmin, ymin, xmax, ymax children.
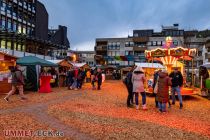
<box><xmin>125</xmin><ymin>69</ymin><xmax>134</xmax><ymax>107</ymax></box>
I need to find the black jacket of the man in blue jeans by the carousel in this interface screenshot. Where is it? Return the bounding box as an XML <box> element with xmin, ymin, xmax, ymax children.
<box><xmin>169</xmin><ymin>71</ymin><xmax>183</xmax><ymax>87</ymax></box>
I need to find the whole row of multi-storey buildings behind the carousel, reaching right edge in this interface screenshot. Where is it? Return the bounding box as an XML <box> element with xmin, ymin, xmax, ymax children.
<box><xmin>95</xmin><ymin>24</ymin><xmax>210</xmax><ymax>69</ymax></box>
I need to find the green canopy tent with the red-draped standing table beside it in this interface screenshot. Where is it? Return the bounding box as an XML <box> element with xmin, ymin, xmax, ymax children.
<box><xmin>17</xmin><ymin>56</ymin><xmax>57</xmax><ymax>93</ymax></box>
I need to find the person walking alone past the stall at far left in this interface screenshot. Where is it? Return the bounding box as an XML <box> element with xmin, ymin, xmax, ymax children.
<box><xmin>4</xmin><ymin>65</ymin><xmax>27</xmax><ymax>102</ymax></box>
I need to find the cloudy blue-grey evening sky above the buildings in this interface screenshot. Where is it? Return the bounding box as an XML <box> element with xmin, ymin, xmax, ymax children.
<box><xmin>40</xmin><ymin>0</ymin><xmax>210</xmax><ymax>50</ymax></box>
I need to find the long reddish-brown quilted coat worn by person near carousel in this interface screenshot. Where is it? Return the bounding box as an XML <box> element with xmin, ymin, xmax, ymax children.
<box><xmin>157</xmin><ymin>72</ymin><xmax>172</xmax><ymax>103</ymax></box>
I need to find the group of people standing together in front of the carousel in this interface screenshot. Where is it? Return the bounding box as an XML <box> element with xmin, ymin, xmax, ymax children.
<box><xmin>124</xmin><ymin>67</ymin><xmax>183</xmax><ymax>112</ymax></box>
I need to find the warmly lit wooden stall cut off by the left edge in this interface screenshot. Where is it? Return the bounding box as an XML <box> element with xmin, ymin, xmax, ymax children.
<box><xmin>0</xmin><ymin>52</ymin><xmax>17</xmax><ymax>94</ymax></box>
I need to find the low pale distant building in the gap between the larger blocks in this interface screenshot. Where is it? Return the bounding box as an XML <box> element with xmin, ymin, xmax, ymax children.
<box><xmin>73</xmin><ymin>51</ymin><xmax>96</xmax><ymax>67</ymax></box>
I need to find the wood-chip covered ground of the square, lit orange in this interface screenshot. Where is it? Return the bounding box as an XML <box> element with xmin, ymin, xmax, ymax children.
<box><xmin>0</xmin><ymin>81</ymin><xmax>210</xmax><ymax>140</ymax></box>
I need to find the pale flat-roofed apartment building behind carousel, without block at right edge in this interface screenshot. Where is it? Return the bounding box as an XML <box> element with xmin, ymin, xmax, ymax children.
<box><xmin>95</xmin><ymin>24</ymin><xmax>184</xmax><ymax>66</ymax></box>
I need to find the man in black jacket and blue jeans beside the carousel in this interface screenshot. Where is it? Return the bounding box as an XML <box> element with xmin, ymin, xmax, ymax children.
<box><xmin>169</xmin><ymin>68</ymin><xmax>183</xmax><ymax>109</ymax></box>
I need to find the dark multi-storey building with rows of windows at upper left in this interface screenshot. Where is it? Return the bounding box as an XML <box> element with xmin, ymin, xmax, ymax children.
<box><xmin>0</xmin><ymin>0</ymin><xmax>69</xmax><ymax>59</ymax></box>
